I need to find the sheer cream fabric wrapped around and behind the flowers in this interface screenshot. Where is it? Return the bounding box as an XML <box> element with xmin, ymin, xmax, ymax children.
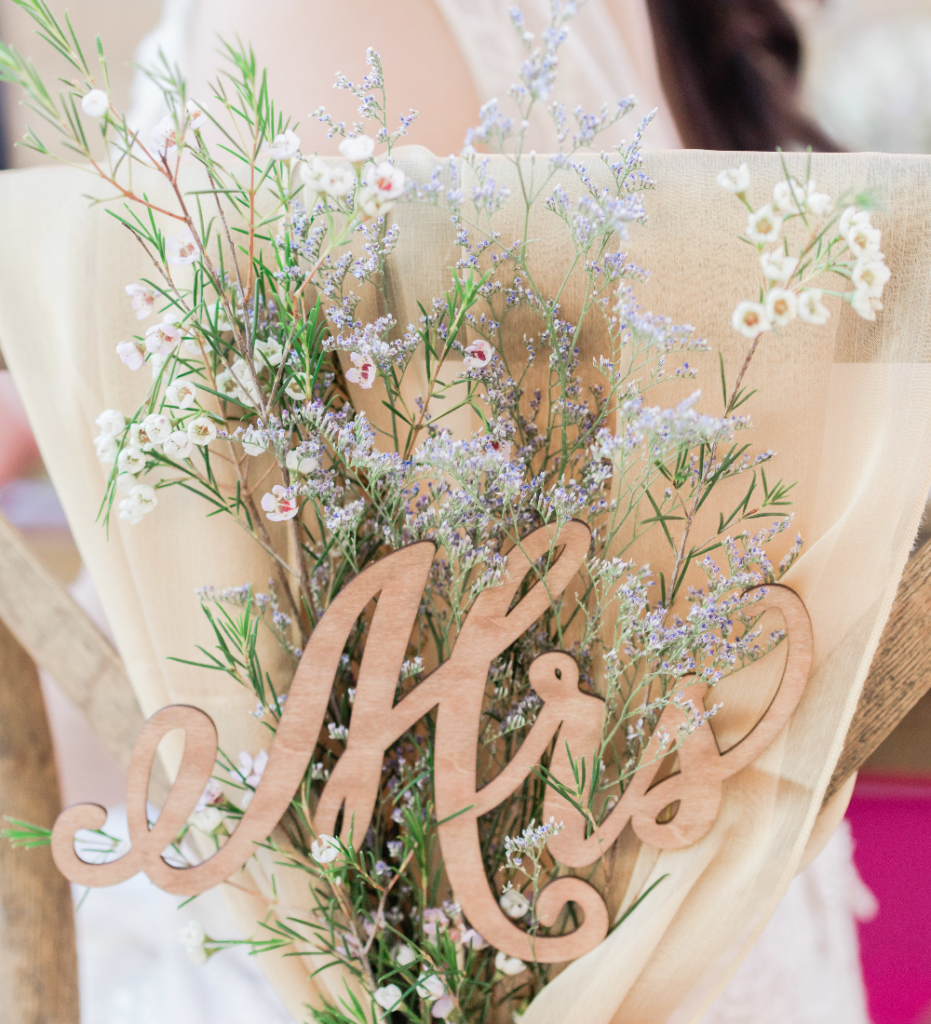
<box><xmin>0</xmin><ymin>150</ymin><xmax>931</xmax><ymax>1024</ymax></box>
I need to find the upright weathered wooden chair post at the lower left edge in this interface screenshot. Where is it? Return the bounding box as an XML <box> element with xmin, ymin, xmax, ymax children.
<box><xmin>0</xmin><ymin>624</ymin><xmax>79</xmax><ymax>1024</ymax></box>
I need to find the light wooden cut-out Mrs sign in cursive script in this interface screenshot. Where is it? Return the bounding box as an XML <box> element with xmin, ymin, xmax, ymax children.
<box><xmin>52</xmin><ymin>521</ymin><xmax>812</xmax><ymax>963</ymax></box>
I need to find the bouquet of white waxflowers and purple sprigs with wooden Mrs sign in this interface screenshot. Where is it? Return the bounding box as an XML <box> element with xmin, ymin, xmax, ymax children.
<box><xmin>0</xmin><ymin>0</ymin><xmax>890</xmax><ymax>1024</ymax></box>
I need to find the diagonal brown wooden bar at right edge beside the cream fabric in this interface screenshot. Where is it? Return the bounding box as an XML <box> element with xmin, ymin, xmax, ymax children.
<box><xmin>824</xmin><ymin>544</ymin><xmax>931</xmax><ymax>803</ymax></box>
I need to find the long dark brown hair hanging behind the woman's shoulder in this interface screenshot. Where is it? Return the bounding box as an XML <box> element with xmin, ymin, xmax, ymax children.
<box><xmin>647</xmin><ymin>0</ymin><xmax>837</xmax><ymax>151</ymax></box>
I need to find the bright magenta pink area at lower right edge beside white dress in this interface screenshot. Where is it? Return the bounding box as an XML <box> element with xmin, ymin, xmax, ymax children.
<box><xmin>847</xmin><ymin>775</ymin><xmax>931</xmax><ymax>1024</ymax></box>
